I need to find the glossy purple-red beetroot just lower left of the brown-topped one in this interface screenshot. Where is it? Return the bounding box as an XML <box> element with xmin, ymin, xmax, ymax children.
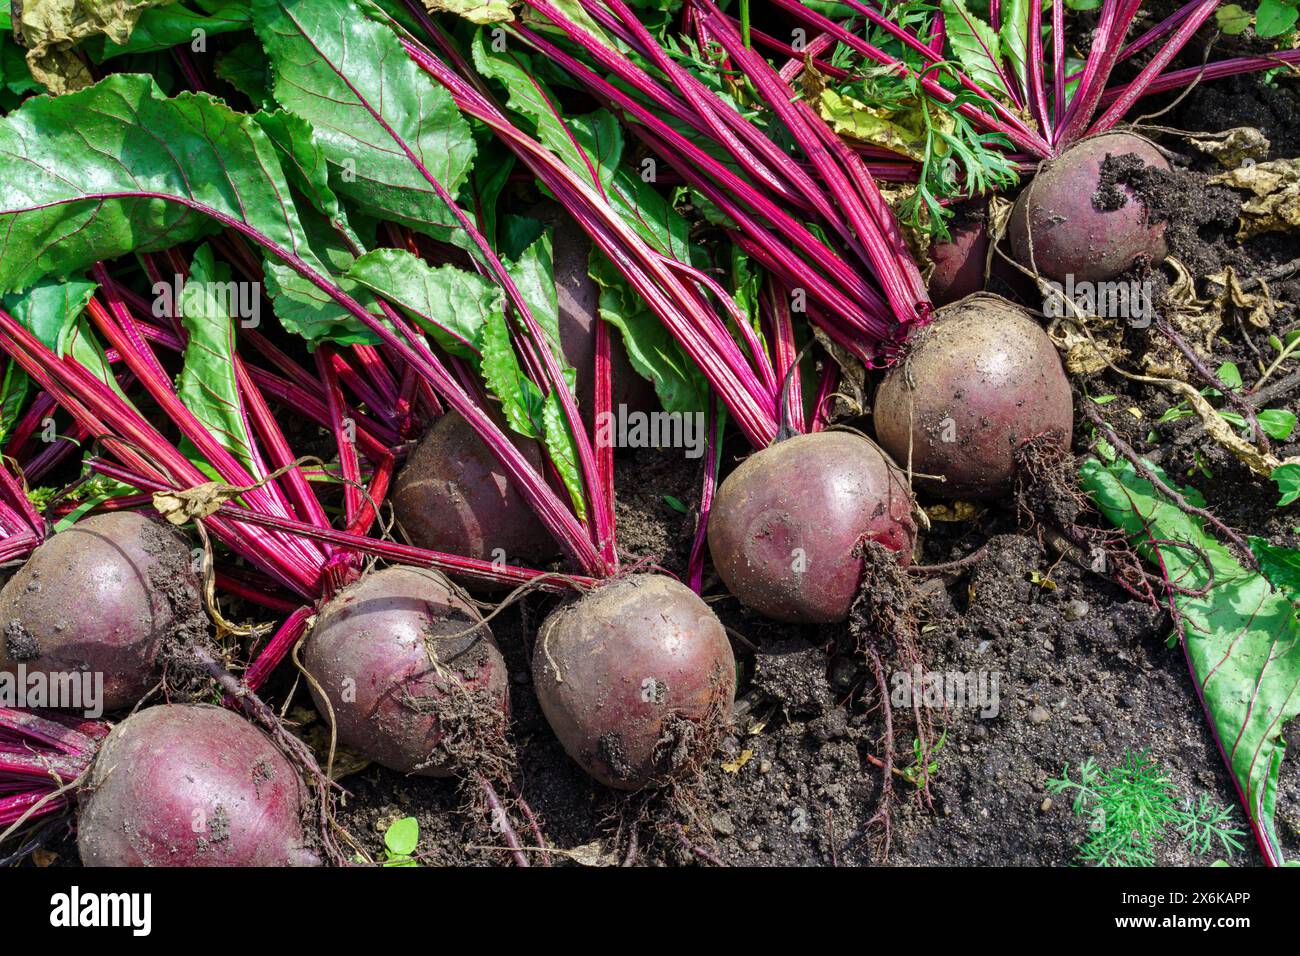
<box><xmin>709</xmin><ymin>432</ymin><xmax>917</xmax><ymax>623</ymax></box>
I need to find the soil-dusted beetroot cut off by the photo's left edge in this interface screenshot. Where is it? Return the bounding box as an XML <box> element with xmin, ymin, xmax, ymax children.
<box><xmin>0</xmin><ymin>511</ymin><xmax>207</xmax><ymax>710</ymax></box>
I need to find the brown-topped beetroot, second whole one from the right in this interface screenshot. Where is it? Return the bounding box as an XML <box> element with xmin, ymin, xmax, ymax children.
<box><xmin>875</xmin><ymin>294</ymin><xmax>1074</xmax><ymax>498</ymax></box>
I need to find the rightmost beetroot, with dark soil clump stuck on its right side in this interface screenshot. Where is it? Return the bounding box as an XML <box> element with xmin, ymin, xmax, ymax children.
<box><xmin>1009</xmin><ymin>133</ymin><xmax>1170</xmax><ymax>282</ymax></box>
